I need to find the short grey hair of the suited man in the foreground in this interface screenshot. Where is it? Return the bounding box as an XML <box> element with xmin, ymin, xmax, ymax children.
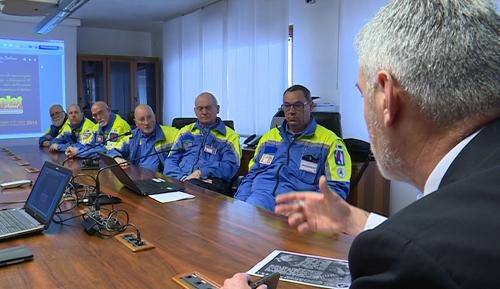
<box><xmin>357</xmin><ymin>0</ymin><xmax>500</xmax><ymax>126</ymax></box>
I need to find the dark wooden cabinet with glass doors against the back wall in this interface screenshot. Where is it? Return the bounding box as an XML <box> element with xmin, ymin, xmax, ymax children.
<box><xmin>78</xmin><ymin>55</ymin><xmax>162</xmax><ymax>120</ymax></box>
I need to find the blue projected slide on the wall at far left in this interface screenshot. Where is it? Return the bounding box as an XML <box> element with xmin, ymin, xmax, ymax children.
<box><xmin>0</xmin><ymin>39</ymin><xmax>66</xmax><ymax>139</ymax></box>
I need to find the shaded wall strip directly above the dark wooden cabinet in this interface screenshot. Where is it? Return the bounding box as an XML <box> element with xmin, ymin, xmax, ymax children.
<box><xmin>78</xmin><ymin>27</ymin><xmax>152</xmax><ymax>56</ymax></box>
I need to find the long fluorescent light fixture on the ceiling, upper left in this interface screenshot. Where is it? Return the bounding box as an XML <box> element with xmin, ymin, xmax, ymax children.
<box><xmin>33</xmin><ymin>0</ymin><xmax>89</xmax><ymax>34</ymax></box>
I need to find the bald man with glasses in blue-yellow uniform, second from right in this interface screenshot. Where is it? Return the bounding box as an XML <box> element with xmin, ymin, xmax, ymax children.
<box><xmin>164</xmin><ymin>92</ymin><xmax>241</xmax><ymax>193</ymax></box>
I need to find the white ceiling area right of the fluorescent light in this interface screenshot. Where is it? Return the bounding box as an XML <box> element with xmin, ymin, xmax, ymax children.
<box><xmin>70</xmin><ymin>0</ymin><xmax>219</xmax><ymax>31</ymax></box>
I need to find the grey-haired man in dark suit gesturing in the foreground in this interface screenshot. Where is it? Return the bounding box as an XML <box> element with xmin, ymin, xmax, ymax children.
<box><xmin>224</xmin><ymin>0</ymin><xmax>500</xmax><ymax>289</ymax></box>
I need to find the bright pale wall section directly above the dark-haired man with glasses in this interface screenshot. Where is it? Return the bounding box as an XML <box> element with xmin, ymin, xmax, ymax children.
<box><xmin>289</xmin><ymin>0</ymin><xmax>340</xmax><ymax>104</ymax></box>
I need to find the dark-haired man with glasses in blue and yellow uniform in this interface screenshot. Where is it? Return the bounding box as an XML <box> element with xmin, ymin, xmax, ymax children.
<box><xmin>235</xmin><ymin>85</ymin><xmax>351</xmax><ymax>211</ymax></box>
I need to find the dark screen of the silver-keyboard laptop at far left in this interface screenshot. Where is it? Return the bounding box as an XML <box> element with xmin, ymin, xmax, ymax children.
<box><xmin>24</xmin><ymin>162</ymin><xmax>73</xmax><ymax>225</ymax></box>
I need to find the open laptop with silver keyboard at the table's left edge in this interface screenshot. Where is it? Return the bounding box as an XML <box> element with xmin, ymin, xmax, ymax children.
<box><xmin>0</xmin><ymin>162</ymin><xmax>73</xmax><ymax>240</ymax></box>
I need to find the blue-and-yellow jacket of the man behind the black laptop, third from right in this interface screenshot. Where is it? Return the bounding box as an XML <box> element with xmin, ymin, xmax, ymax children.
<box><xmin>108</xmin><ymin>124</ymin><xmax>178</xmax><ymax>171</ymax></box>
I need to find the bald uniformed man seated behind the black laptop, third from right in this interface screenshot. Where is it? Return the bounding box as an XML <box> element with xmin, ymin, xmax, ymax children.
<box><xmin>108</xmin><ymin>104</ymin><xmax>178</xmax><ymax>172</ymax></box>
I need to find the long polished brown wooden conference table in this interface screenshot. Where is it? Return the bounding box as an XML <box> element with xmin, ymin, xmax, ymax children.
<box><xmin>0</xmin><ymin>143</ymin><xmax>352</xmax><ymax>288</ymax></box>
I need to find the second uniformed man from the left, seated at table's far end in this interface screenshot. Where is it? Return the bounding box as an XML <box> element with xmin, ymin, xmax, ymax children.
<box><xmin>49</xmin><ymin>104</ymin><xmax>94</xmax><ymax>152</ymax></box>
